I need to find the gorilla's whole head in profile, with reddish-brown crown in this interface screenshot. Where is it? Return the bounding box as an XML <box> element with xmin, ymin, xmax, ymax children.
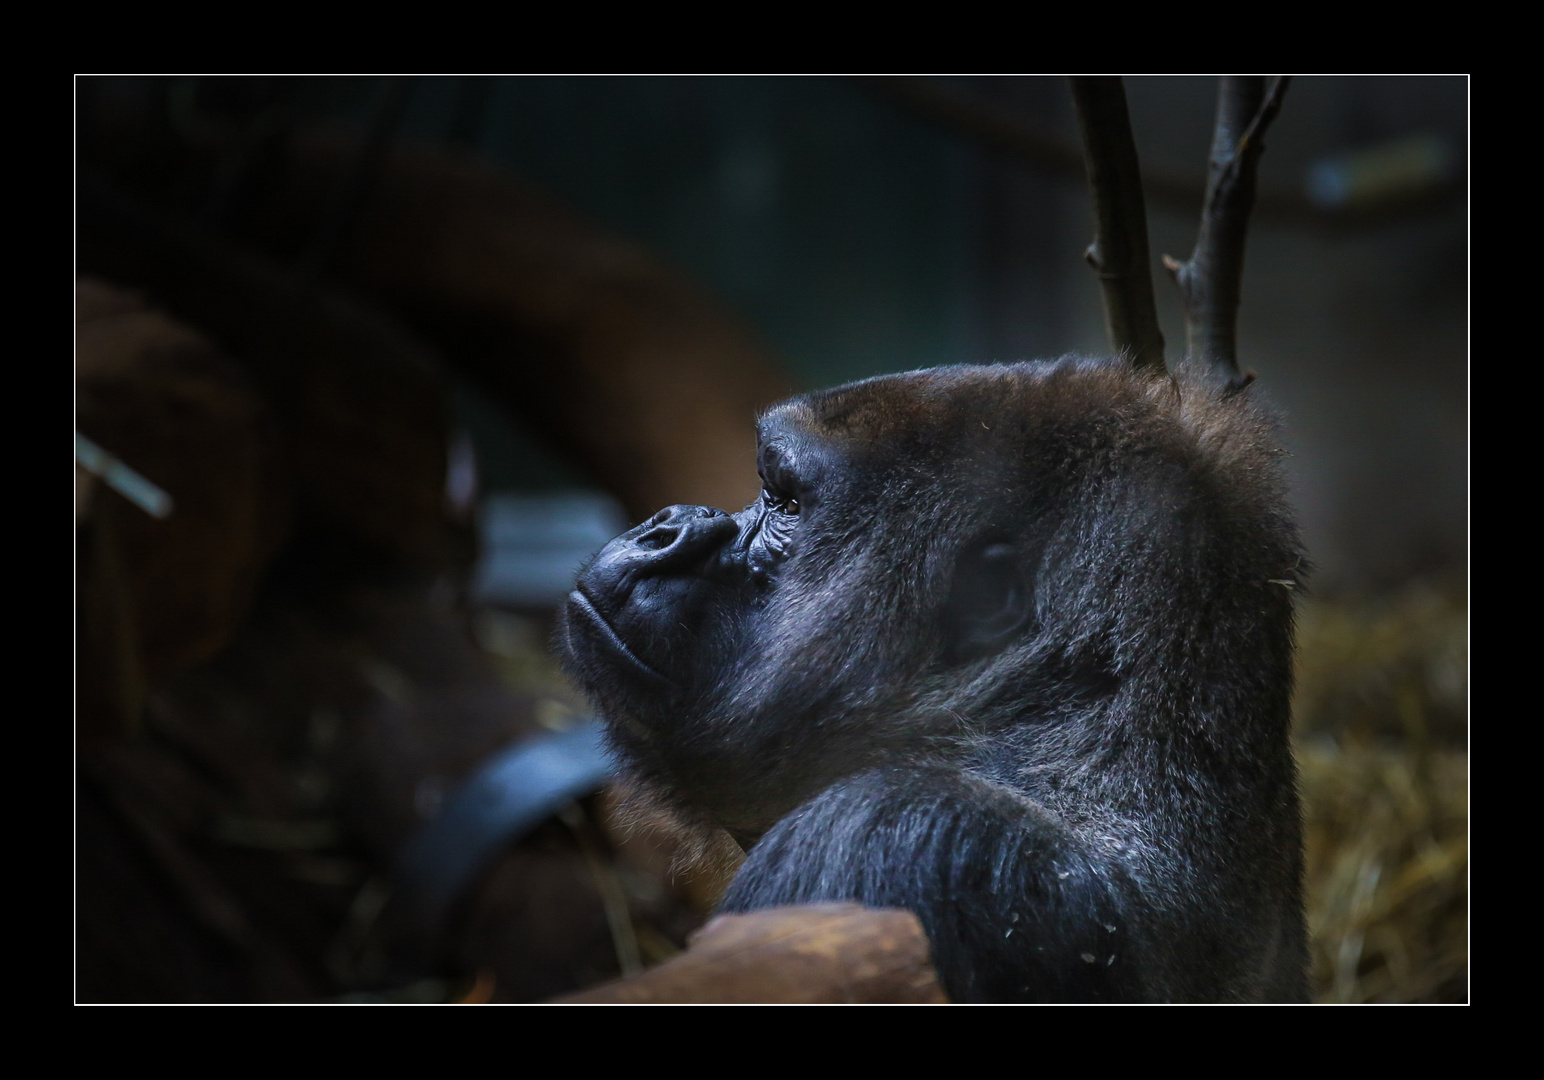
<box><xmin>560</xmin><ymin>358</ymin><xmax>1299</xmax><ymax>837</ymax></box>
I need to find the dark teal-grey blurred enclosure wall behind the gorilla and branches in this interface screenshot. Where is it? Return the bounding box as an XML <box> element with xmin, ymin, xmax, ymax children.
<box><xmin>80</xmin><ymin>77</ymin><xmax>1468</xmax><ymax>593</ymax></box>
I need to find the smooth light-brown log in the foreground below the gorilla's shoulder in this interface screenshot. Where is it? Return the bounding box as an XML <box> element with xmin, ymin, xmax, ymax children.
<box><xmin>559</xmin><ymin>904</ymin><xmax>948</xmax><ymax>1004</ymax></box>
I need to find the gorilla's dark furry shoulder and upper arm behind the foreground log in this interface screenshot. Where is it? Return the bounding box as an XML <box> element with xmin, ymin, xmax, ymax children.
<box><xmin>720</xmin><ymin>768</ymin><xmax>1150</xmax><ymax>1001</ymax></box>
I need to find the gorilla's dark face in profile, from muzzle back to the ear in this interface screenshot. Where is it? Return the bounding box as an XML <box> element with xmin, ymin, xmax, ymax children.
<box><xmin>560</xmin><ymin>369</ymin><xmax>1056</xmax><ymax>833</ymax></box>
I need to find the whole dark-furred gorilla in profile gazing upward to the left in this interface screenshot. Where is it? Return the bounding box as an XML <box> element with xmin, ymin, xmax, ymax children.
<box><xmin>559</xmin><ymin>357</ymin><xmax>1308</xmax><ymax>1001</ymax></box>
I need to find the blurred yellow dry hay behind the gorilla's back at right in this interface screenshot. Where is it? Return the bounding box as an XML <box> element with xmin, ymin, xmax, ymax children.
<box><xmin>1295</xmin><ymin>589</ymin><xmax>1468</xmax><ymax>1001</ymax></box>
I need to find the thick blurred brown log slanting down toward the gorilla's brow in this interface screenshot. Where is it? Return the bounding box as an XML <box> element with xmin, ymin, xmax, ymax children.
<box><xmin>256</xmin><ymin>131</ymin><xmax>792</xmax><ymax>519</ymax></box>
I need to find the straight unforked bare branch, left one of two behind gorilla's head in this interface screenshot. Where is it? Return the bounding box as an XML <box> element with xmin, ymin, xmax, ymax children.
<box><xmin>1068</xmin><ymin>76</ymin><xmax>1166</xmax><ymax>372</ymax></box>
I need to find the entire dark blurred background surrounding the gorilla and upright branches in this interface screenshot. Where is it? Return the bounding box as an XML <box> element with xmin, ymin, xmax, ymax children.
<box><xmin>76</xmin><ymin>77</ymin><xmax>1468</xmax><ymax>1001</ymax></box>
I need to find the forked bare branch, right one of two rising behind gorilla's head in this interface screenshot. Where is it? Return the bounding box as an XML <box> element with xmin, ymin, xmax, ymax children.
<box><xmin>1163</xmin><ymin>76</ymin><xmax>1289</xmax><ymax>386</ymax></box>
